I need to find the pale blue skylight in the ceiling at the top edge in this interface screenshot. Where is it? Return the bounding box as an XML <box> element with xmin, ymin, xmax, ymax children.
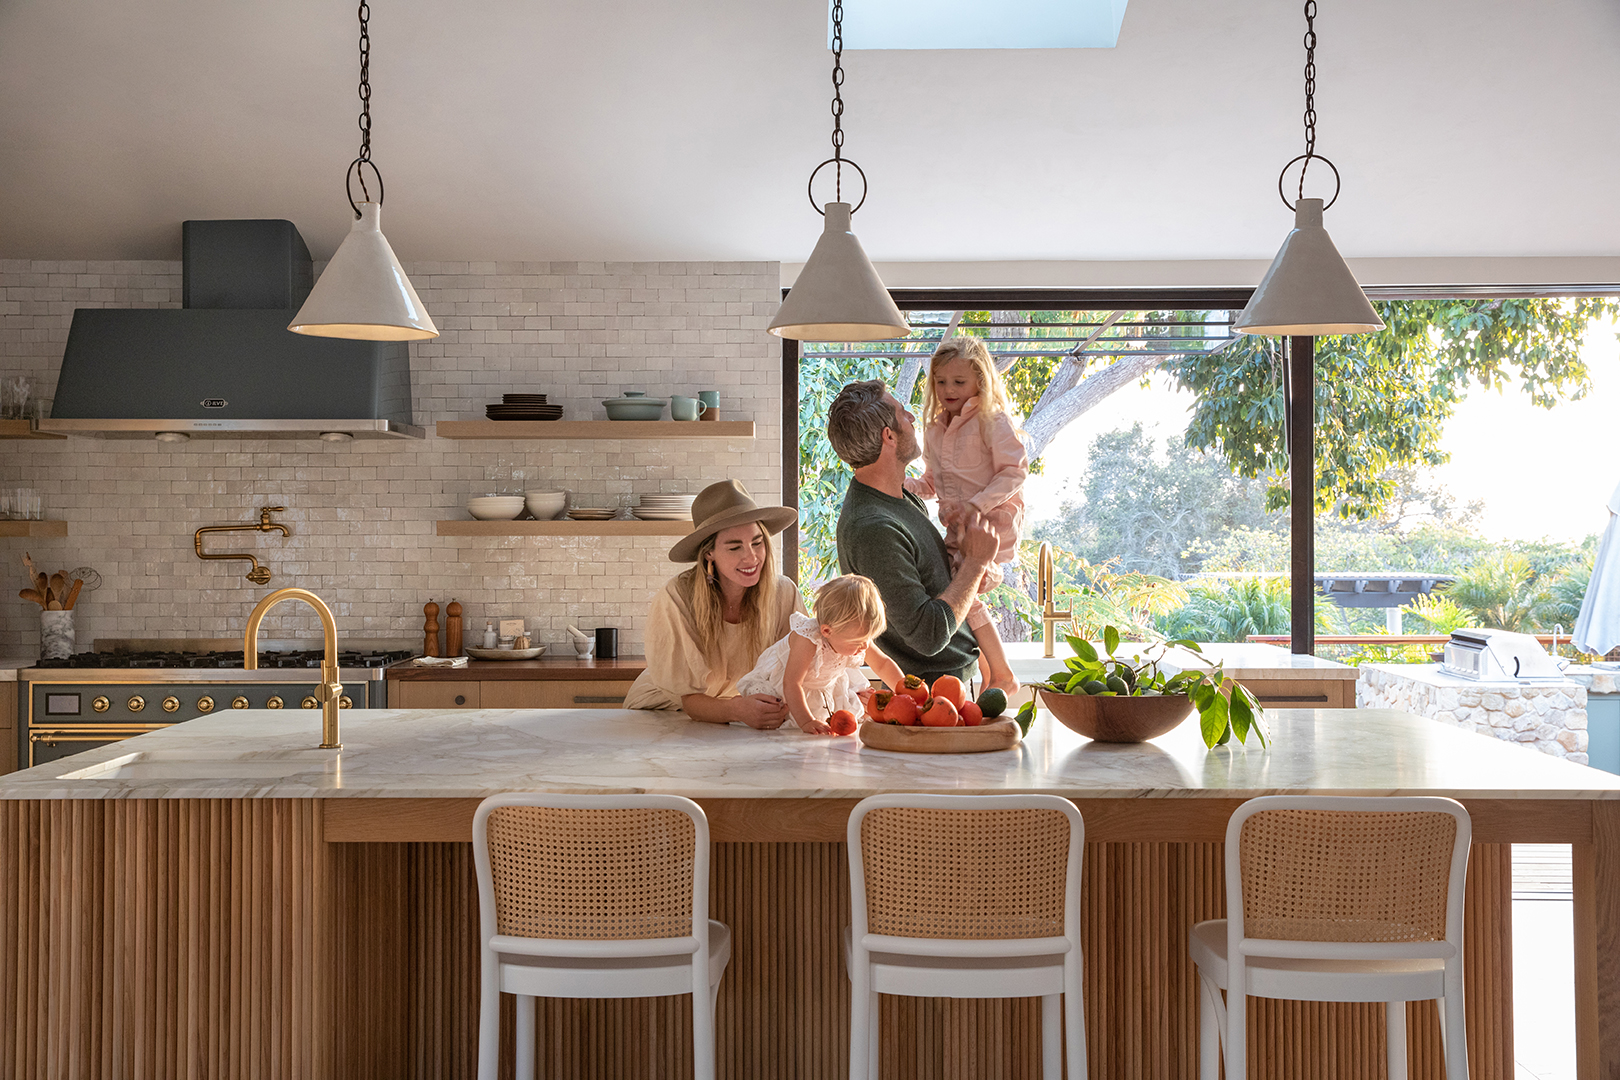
<box><xmin>826</xmin><ymin>0</ymin><xmax>1129</xmax><ymax>49</ymax></box>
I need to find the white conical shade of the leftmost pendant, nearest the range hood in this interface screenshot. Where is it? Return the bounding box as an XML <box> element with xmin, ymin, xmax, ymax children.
<box><xmin>287</xmin><ymin>202</ymin><xmax>439</xmax><ymax>342</ymax></box>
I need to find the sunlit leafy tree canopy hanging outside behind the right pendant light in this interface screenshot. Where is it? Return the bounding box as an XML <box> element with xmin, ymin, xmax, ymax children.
<box><xmin>1163</xmin><ymin>298</ymin><xmax>1620</xmax><ymax>520</ymax></box>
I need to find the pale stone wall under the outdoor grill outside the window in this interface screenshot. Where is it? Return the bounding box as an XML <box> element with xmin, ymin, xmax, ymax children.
<box><xmin>1356</xmin><ymin>664</ymin><xmax>1588</xmax><ymax>764</ymax></box>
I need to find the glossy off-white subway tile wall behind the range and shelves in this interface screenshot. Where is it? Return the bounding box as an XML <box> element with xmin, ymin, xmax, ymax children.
<box><xmin>0</xmin><ymin>261</ymin><xmax>782</xmax><ymax>656</ymax></box>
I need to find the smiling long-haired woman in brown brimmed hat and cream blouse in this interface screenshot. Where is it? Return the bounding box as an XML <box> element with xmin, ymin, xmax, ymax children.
<box><xmin>624</xmin><ymin>481</ymin><xmax>805</xmax><ymax>730</ymax></box>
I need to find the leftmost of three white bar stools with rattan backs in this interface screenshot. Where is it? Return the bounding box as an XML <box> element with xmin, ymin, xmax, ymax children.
<box><xmin>473</xmin><ymin>793</ymin><xmax>731</xmax><ymax>1080</ymax></box>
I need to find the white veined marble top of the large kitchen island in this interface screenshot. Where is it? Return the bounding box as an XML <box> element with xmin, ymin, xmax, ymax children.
<box><xmin>0</xmin><ymin>709</ymin><xmax>1620</xmax><ymax>800</ymax></box>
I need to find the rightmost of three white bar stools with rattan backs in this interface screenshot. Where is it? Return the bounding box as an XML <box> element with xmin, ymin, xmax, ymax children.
<box><xmin>1191</xmin><ymin>795</ymin><xmax>1471</xmax><ymax>1080</ymax></box>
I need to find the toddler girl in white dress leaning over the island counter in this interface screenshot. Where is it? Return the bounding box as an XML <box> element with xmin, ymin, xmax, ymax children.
<box><xmin>737</xmin><ymin>573</ymin><xmax>904</xmax><ymax>735</ymax></box>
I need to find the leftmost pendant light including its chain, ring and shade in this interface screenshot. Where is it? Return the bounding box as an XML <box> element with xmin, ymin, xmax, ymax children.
<box><xmin>287</xmin><ymin>2</ymin><xmax>439</xmax><ymax>342</ymax></box>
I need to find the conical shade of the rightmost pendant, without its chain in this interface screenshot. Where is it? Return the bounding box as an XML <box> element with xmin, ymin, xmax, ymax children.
<box><xmin>1233</xmin><ymin>199</ymin><xmax>1383</xmax><ymax>337</ymax></box>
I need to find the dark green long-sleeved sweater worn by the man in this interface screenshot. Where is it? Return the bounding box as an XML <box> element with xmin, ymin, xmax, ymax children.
<box><xmin>838</xmin><ymin>479</ymin><xmax>978</xmax><ymax>683</ymax></box>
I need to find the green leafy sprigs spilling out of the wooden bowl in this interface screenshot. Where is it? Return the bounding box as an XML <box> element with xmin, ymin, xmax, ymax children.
<box><xmin>1019</xmin><ymin>627</ymin><xmax>1268</xmax><ymax>748</ymax></box>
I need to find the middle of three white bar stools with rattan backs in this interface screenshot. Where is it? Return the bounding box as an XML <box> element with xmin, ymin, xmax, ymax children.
<box><xmin>844</xmin><ymin>795</ymin><xmax>1085</xmax><ymax>1080</ymax></box>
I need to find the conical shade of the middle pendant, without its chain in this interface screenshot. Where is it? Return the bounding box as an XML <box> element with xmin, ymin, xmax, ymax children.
<box><xmin>770</xmin><ymin>202</ymin><xmax>910</xmax><ymax>342</ymax></box>
